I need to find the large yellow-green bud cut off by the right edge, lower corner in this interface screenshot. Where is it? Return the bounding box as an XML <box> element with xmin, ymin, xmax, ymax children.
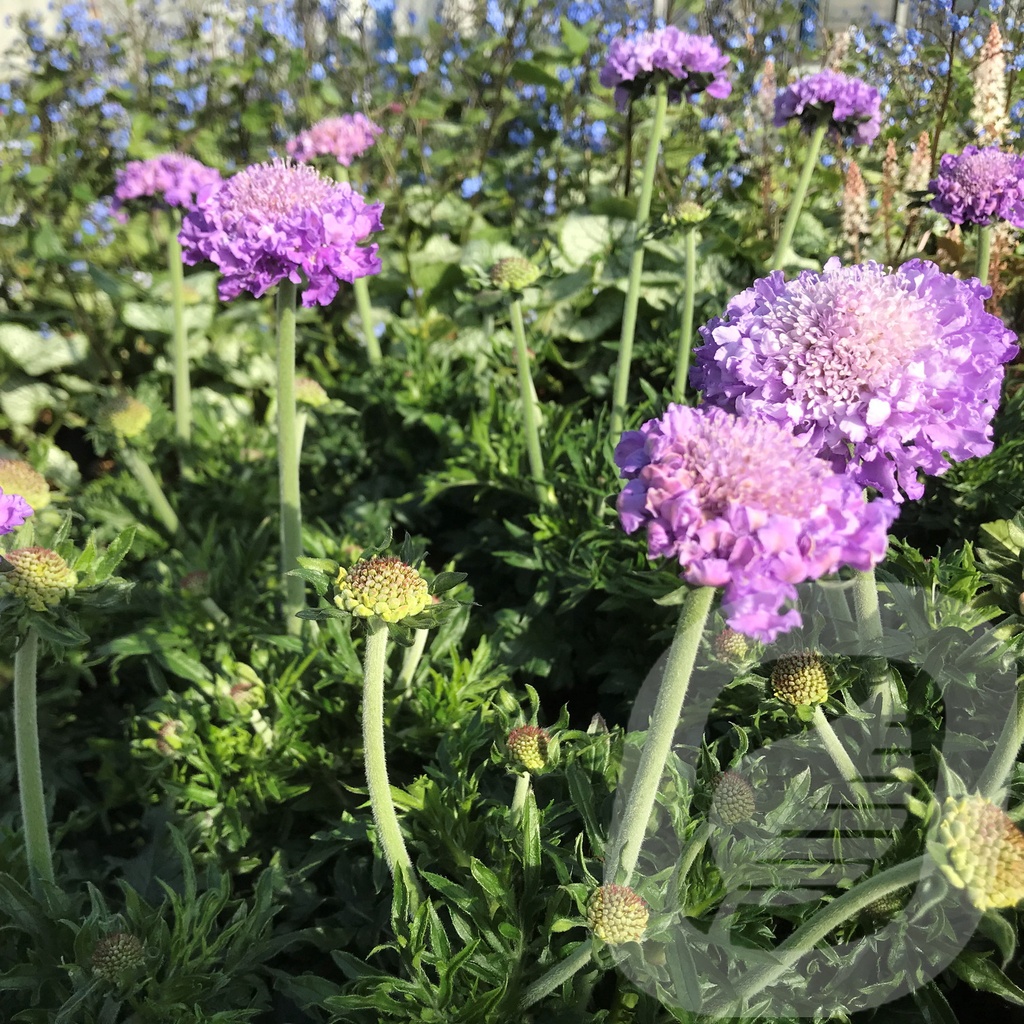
<box><xmin>930</xmin><ymin>795</ymin><xmax>1024</xmax><ymax>910</ymax></box>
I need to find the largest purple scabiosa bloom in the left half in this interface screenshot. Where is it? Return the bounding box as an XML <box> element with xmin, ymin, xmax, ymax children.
<box><xmin>179</xmin><ymin>160</ymin><xmax>384</xmax><ymax>306</ymax></box>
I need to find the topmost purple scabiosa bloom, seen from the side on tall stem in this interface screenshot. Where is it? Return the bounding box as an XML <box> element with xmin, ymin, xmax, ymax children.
<box><xmin>600</xmin><ymin>25</ymin><xmax>732</xmax><ymax>111</ymax></box>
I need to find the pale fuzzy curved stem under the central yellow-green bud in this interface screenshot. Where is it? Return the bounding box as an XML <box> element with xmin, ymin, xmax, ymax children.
<box><xmin>362</xmin><ymin>620</ymin><xmax>423</xmax><ymax>913</ymax></box>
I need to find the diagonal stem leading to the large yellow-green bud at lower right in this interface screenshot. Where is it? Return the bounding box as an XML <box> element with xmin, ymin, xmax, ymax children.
<box><xmin>700</xmin><ymin>857</ymin><xmax>929</xmax><ymax>1018</ymax></box>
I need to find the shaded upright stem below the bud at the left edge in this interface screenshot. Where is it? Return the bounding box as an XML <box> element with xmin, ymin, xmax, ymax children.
<box><xmin>14</xmin><ymin>629</ymin><xmax>53</xmax><ymax>894</ymax></box>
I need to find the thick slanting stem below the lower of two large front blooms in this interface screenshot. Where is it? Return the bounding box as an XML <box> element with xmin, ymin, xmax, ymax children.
<box><xmin>605</xmin><ymin>587</ymin><xmax>715</xmax><ymax>885</ymax></box>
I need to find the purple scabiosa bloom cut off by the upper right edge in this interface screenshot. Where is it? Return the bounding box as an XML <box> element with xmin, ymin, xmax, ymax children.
<box><xmin>928</xmin><ymin>145</ymin><xmax>1024</xmax><ymax>227</ymax></box>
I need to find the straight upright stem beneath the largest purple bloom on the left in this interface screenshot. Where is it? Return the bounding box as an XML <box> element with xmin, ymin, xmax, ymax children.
<box><xmin>278</xmin><ymin>280</ymin><xmax>305</xmax><ymax>634</ymax></box>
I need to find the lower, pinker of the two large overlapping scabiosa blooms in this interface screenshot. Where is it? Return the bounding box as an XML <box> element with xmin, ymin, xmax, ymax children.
<box><xmin>615</xmin><ymin>404</ymin><xmax>896</xmax><ymax>643</ymax></box>
